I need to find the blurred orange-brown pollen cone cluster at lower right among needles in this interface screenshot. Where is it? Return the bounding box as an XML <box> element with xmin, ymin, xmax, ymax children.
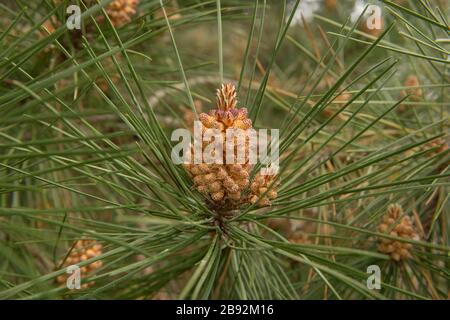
<box><xmin>377</xmin><ymin>204</ymin><xmax>419</xmax><ymax>261</ymax></box>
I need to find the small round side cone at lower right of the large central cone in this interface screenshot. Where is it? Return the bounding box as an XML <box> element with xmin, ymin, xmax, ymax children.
<box><xmin>249</xmin><ymin>173</ymin><xmax>278</xmax><ymax>207</ymax></box>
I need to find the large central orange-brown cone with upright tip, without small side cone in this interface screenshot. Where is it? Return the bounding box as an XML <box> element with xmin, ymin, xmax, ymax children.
<box><xmin>185</xmin><ymin>84</ymin><xmax>252</xmax><ymax>204</ymax></box>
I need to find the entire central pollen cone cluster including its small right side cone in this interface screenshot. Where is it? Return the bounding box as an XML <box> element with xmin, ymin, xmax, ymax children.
<box><xmin>185</xmin><ymin>84</ymin><xmax>277</xmax><ymax>207</ymax></box>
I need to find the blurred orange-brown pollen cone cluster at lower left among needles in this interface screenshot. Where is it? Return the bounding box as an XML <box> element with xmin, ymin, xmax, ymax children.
<box><xmin>56</xmin><ymin>239</ymin><xmax>103</xmax><ymax>289</ymax></box>
